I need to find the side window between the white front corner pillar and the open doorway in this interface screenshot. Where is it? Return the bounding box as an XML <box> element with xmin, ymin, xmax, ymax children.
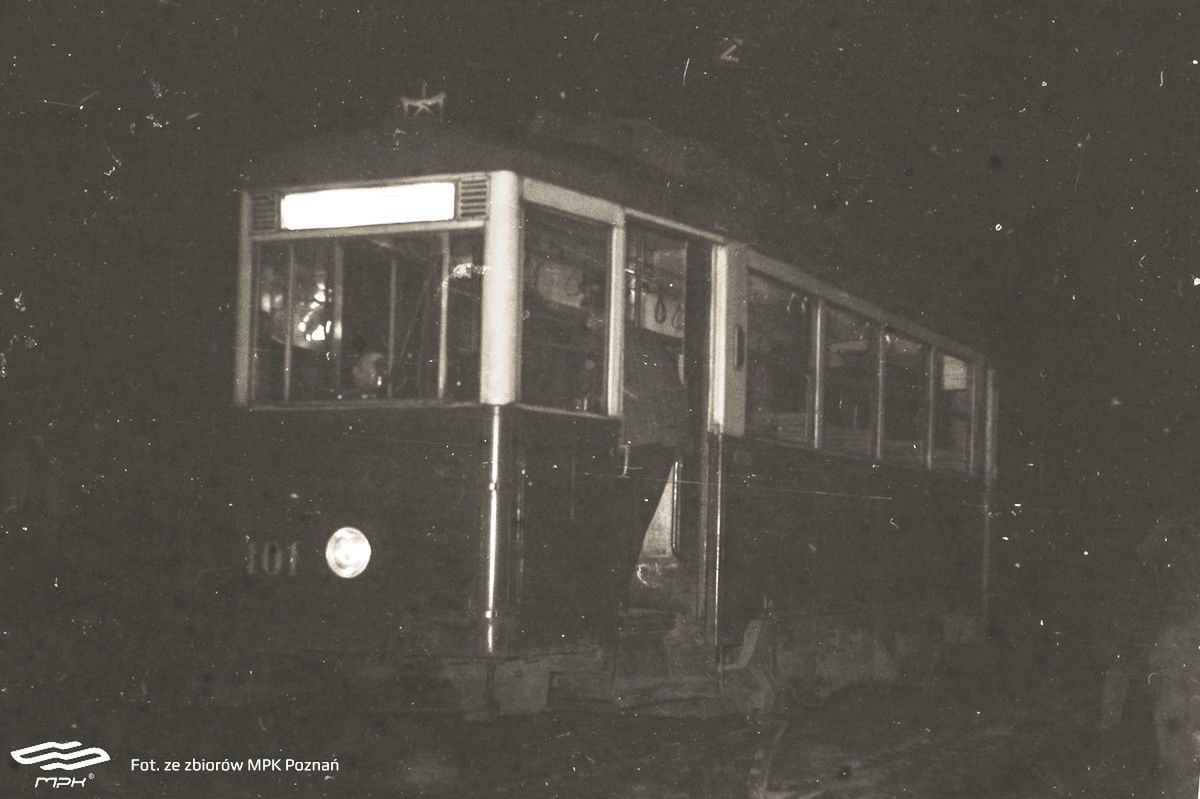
<box><xmin>521</xmin><ymin>208</ymin><xmax>612</xmax><ymax>413</ymax></box>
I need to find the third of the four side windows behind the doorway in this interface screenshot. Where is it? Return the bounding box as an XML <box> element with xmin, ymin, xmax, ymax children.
<box><xmin>883</xmin><ymin>331</ymin><xmax>929</xmax><ymax>464</ymax></box>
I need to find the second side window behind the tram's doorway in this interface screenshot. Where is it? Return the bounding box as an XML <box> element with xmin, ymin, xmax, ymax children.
<box><xmin>822</xmin><ymin>307</ymin><xmax>877</xmax><ymax>456</ymax></box>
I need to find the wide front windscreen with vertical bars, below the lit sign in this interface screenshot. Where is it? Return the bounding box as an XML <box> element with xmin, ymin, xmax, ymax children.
<box><xmin>253</xmin><ymin>233</ymin><xmax>482</xmax><ymax>403</ymax></box>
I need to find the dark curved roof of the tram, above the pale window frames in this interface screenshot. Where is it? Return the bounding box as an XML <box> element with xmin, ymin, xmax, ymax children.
<box><xmin>250</xmin><ymin>116</ymin><xmax>977</xmax><ymax>355</ymax></box>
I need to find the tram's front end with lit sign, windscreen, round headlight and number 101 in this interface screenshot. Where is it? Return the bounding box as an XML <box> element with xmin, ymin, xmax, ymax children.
<box><xmin>214</xmin><ymin>166</ymin><xmax>566</xmax><ymax>710</ymax></box>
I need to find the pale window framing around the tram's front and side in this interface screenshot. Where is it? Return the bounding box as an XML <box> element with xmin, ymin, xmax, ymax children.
<box><xmin>234</xmin><ymin>172</ymin><xmax>996</xmax><ymax>479</ymax></box>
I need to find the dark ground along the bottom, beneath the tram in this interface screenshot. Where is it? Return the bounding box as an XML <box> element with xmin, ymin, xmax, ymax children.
<box><xmin>2</xmin><ymin>657</ymin><xmax>1157</xmax><ymax>799</ymax></box>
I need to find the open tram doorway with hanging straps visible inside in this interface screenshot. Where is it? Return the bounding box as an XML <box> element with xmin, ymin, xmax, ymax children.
<box><xmin>623</xmin><ymin>224</ymin><xmax>713</xmax><ymax>561</ymax></box>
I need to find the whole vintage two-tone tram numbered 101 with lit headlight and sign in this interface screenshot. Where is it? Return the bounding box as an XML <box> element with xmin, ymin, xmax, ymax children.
<box><xmin>223</xmin><ymin>118</ymin><xmax>996</xmax><ymax>714</ymax></box>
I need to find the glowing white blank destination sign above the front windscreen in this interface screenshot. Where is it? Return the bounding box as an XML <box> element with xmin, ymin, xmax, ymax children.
<box><xmin>280</xmin><ymin>184</ymin><xmax>455</xmax><ymax>230</ymax></box>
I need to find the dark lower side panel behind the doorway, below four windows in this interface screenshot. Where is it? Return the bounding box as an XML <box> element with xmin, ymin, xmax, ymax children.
<box><xmin>719</xmin><ymin>438</ymin><xmax>983</xmax><ymax>696</ymax></box>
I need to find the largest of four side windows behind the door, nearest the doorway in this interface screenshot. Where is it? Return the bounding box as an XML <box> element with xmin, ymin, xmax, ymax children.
<box><xmin>746</xmin><ymin>272</ymin><xmax>816</xmax><ymax>444</ymax></box>
